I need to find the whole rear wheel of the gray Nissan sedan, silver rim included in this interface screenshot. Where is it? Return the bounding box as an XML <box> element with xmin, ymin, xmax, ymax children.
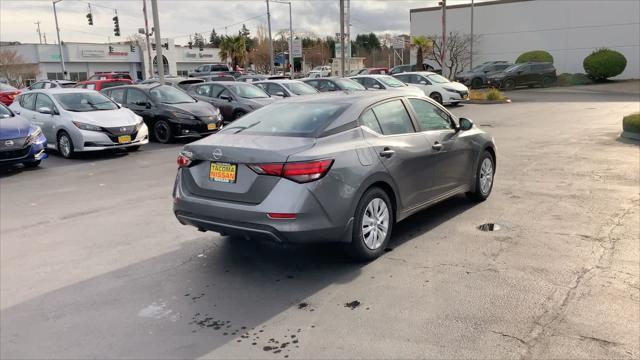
<box><xmin>351</xmin><ymin>187</ymin><xmax>394</xmax><ymax>260</ymax></box>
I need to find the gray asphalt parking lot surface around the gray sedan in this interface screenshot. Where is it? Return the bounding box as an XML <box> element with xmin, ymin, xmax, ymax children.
<box><xmin>0</xmin><ymin>83</ymin><xmax>640</xmax><ymax>359</ymax></box>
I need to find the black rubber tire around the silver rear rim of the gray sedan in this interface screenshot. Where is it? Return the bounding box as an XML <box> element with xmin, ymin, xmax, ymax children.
<box><xmin>350</xmin><ymin>187</ymin><xmax>395</xmax><ymax>261</ymax></box>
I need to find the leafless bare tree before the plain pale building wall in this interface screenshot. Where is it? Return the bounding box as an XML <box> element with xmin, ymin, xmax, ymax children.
<box><xmin>427</xmin><ymin>32</ymin><xmax>478</xmax><ymax>77</ymax></box>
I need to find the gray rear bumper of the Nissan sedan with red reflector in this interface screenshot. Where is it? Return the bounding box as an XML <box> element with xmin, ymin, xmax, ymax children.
<box><xmin>173</xmin><ymin>170</ymin><xmax>352</xmax><ymax>243</ymax></box>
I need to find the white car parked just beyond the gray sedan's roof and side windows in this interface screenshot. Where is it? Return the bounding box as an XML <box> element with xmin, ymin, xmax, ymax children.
<box><xmin>393</xmin><ymin>71</ymin><xmax>469</xmax><ymax>105</ymax></box>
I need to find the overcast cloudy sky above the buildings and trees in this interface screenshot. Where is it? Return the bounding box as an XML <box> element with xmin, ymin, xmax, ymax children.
<box><xmin>0</xmin><ymin>0</ymin><xmax>470</xmax><ymax>44</ymax></box>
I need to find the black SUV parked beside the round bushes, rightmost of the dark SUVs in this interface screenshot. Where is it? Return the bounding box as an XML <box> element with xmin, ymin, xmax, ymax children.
<box><xmin>487</xmin><ymin>62</ymin><xmax>556</xmax><ymax>90</ymax></box>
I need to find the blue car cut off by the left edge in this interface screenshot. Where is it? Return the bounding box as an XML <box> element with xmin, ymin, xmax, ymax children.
<box><xmin>0</xmin><ymin>104</ymin><xmax>47</xmax><ymax>168</ymax></box>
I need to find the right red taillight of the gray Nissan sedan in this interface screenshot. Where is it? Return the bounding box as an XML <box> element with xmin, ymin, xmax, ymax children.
<box><xmin>248</xmin><ymin>160</ymin><xmax>333</xmax><ymax>183</ymax></box>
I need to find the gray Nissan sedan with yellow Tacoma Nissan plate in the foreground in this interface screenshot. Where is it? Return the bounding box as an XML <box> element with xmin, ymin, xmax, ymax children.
<box><xmin>173</xmin><ymin>91</ymin><xmax>496</xmax><ymax>259</ymax></box>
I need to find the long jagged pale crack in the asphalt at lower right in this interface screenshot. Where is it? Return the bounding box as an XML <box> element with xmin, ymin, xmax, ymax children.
<box><xmin>521</xmin><ymin>204</ymin><xmax>635</xmax><ymax>359</ymax></box>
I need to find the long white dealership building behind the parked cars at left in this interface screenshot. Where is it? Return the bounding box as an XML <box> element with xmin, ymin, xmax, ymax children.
<box><xmin>2</xmin><ymin>39</ymin><xmax>220</xmax><ymax>82</ymax></box>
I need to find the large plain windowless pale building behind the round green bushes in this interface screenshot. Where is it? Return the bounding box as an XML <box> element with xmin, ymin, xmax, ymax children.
<box><xmin>410</xmin><ymin>0</ymin><xmax>640</xmax><ymax>79</ymax></box>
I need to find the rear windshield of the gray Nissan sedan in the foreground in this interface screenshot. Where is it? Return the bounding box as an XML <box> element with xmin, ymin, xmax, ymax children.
<box><xmin>221</xmin><ymin>102</ymin><xmax>349</xmax><ymax>137</ymax></box>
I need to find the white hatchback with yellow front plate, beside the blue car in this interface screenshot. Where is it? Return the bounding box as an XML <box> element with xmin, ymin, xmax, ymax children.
<box><xmin>10</xmin><ymin>88</ymin><xmax>149</xmax><ymax>158</ymax></box>
